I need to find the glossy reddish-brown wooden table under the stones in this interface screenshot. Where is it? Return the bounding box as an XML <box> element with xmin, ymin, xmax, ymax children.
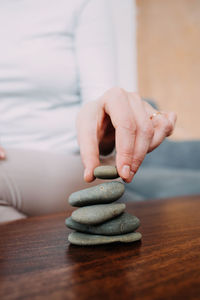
<box><xmin>0</xmin><ymin>196</ymin><xmax>200</xmax><ymax>300</ymax></box>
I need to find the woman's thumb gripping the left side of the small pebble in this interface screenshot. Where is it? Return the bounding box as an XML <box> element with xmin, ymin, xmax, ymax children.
<box><xmin>77</xmin><ymin>104</ymin><xmax>100</xmax><ymax>182</ymax></box>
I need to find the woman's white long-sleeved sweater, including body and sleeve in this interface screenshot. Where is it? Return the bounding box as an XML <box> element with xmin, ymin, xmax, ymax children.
<box><xmin>0</xmin><ymin>0</ymin><xmax>117</xmax><ymax>152</ymax></box>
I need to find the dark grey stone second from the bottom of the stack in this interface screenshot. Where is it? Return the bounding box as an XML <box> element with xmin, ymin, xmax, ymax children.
<box><xmin>65</xmin><ymin>212</ymin><xmax>140</xmax><ymax>235</ymax></box>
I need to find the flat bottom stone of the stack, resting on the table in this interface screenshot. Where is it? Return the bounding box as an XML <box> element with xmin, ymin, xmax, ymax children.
<box><xmin>68</xmin><ymin>232</ymin><xmax>142</xmax><ymax>246</ymax></box>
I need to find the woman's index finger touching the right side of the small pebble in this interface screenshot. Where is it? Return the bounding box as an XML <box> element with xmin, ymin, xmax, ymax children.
<box><xmin>104</xmin><ymin>89</ymin><xmax>136</xmax><ymax>181</ymax></box>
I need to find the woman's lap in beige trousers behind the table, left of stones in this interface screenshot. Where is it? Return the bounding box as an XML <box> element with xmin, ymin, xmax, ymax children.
<box><xmin>0</xmin><ymin>149</ymin><xmax>99</xmax><ymax>222</ymax></box>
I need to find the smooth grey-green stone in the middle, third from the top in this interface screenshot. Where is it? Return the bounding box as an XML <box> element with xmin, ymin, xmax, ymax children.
<box><xmin>71</xmin><ymin>203</ymin><xmax>126</xmax><ymax>225</ymax></box>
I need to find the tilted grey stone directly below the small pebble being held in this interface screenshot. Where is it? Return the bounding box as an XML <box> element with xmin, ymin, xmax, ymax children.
<box><xmin>68</xmin><ymin>181</ymin><xmax>124</xmax><ymax>207</ymax></box>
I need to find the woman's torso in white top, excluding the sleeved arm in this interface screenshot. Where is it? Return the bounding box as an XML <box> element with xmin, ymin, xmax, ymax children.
<box><xmin>0</xmin><ymin>0</ymin><xmax>85</xmax><ymax>151</ymax></box>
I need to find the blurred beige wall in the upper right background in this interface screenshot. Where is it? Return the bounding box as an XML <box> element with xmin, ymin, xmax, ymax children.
<box><xmin>137</xmin><ymin>0</ymin><xmax>200</xmax><ymax>139</ymax></box>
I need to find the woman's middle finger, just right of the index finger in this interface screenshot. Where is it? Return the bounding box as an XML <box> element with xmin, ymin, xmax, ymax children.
<box><xmin>129</xmin><ymin>93</ymin><xmax>154</xmax><ymax>173</ymax></box>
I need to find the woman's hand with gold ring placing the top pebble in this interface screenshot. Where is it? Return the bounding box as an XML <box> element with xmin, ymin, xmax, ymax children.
<box><xmin>77</xmin><ymin>88</ymin><xmax>176</xmax><ymax>182</ymax></box>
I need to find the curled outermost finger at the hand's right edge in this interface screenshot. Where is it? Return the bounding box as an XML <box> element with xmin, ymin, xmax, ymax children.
<box><xmin>148</xmin><ymin>113</ymin><xmax>176</xmax><ymax>152</ymax></box>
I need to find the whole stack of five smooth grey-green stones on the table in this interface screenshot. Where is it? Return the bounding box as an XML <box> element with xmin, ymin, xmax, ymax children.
<box><xmin>65</xmin><ymin>166</ymin><xmax>142</xmax><ymax>246</ymax></box>
